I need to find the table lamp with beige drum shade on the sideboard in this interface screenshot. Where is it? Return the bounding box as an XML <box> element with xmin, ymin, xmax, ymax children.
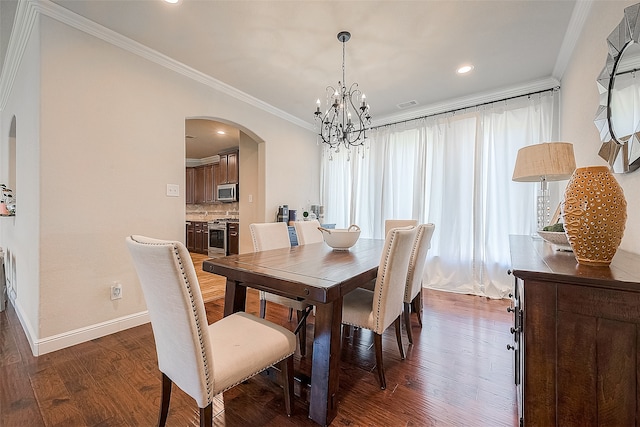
<box><xmin>511</xmin><ymin>142</ymin><xmax>576</xmax><ymax>230</ymax></box>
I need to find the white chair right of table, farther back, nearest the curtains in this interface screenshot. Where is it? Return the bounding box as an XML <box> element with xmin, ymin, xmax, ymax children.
<box><xmin>404</xmin><ymin>224</ymin><xmax>436</xmax><ymax>344</ymax></box>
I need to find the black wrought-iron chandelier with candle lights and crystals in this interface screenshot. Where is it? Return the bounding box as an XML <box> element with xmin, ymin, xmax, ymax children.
<box><xmin>314</xmin><ymin>31</ymin><xmax>371</xmax><ymax>152</ymax></box>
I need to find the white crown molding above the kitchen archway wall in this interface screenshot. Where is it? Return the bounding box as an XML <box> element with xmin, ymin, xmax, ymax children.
<box><xmin>0</xmin><ymin>0</ymin><xmax>313</xmax><ymax>130</ymax></box>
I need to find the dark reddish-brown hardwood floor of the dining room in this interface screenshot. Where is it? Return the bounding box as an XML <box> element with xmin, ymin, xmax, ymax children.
<box><xmin>0</xmin><ymin>262</ymin><xmax>517</xmax><ymax>427</ymax></box>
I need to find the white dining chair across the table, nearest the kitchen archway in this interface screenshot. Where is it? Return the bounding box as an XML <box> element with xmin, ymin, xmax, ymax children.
<box><xmin>249</xmin><ymin>222</ymin><xmax>313</xmax><ymax>356</ymax></box>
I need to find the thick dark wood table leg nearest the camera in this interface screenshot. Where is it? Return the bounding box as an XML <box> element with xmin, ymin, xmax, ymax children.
<box><xmin>309</xmin><ymin>298</ymin><xmax>342</xmax><ymax>426</ymax></box>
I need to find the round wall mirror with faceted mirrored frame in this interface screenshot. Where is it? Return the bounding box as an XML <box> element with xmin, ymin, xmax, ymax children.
<box><xmin>594</xmin><ymin>3</ymin><xmax>640</xmax><ymax>173</ymax></box>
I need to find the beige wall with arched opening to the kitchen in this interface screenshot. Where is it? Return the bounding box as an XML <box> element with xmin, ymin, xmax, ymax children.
<box><xmin>2</xmin><ymin>16</ymin><xmax>319</xmax><ymax>353</ymax></box>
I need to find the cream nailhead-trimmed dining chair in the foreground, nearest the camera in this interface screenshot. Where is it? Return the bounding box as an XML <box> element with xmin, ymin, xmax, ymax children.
<box><xmin>126</xmin><ymin>236</ymin><xmax>296</xmax><ymax>427</ymax></box>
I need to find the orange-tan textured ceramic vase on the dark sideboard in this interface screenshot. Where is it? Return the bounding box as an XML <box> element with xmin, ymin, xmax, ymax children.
<box><xmin>562</xmin><ymin>166</ymin><xmax>627</xmax><ymax>266</ymax></box>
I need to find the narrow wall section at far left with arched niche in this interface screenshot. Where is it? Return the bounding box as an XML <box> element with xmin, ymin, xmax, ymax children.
<box><xmin>0</xmin><ymin>11</ymin><xmax>41</xmax><ymax>346</ymax></box>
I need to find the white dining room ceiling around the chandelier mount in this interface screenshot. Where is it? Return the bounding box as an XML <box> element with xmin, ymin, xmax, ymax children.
<box><xmin>48</xmin><ymin>0</ymin><xmax>580</xmax><ymax>157</ymax></box>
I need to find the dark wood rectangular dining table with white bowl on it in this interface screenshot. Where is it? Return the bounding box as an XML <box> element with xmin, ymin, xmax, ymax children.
<box><xmin>203</xmin><ymin>239</ymin><xmax>384</xmax><ymax>426</ymax></box>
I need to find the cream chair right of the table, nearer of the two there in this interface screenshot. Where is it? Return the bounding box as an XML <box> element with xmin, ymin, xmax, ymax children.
<box><xmin>342</xmin><ymin>227</ymin><xmax>417</xmax><ymax>390</ymax></box>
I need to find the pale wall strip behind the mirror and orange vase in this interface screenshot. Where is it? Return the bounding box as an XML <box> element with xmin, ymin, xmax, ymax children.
<box><xmin>560</xmin><ymin>1</ymin><xmax>640</xmax><ymax>253</ymax></box>
